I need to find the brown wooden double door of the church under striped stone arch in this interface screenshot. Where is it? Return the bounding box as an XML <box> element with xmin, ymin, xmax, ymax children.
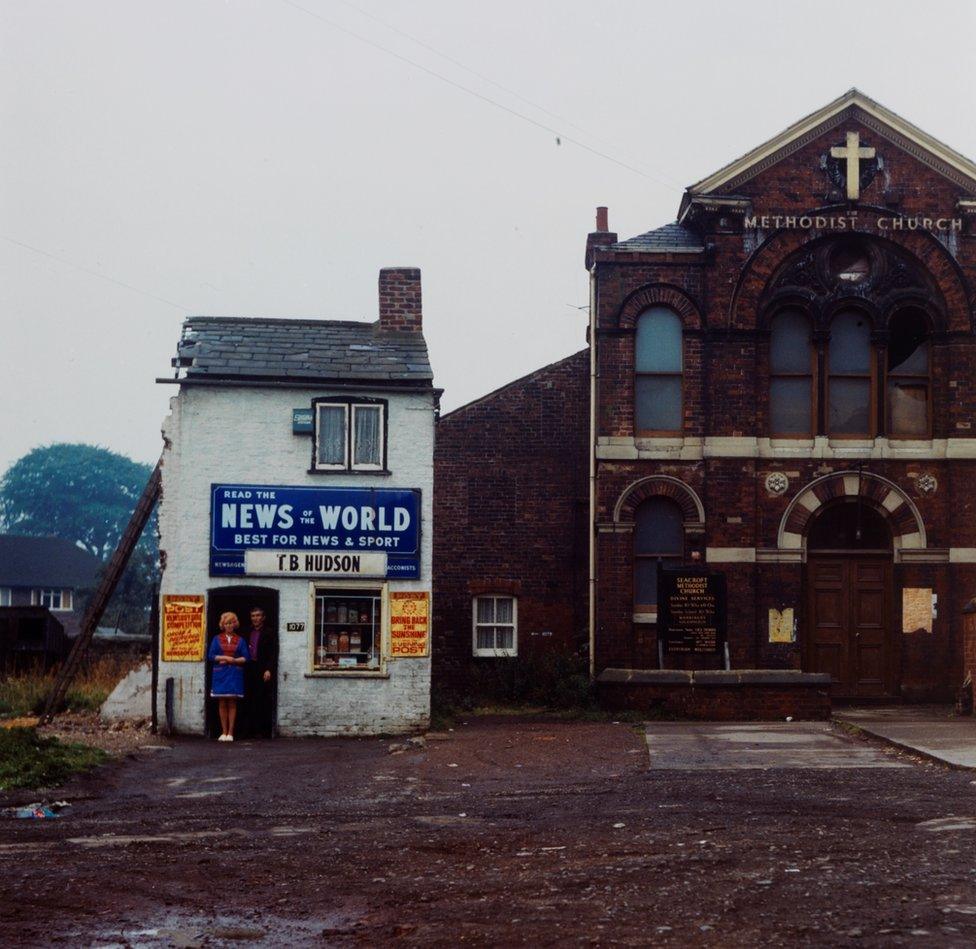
<box><xmin>803</xmin><ymin>498</ymin><xmax>898</xmax><ymax>699</ymax></box>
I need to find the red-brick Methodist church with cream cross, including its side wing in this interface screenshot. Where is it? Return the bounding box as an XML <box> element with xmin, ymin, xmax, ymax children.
<box><xmin>434</xmin><ymin>90</ymin><xmax>976</xmax><ymax>712</ymax></box>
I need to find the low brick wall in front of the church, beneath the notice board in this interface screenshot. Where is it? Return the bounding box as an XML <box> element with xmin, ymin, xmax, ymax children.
<box><xmin>597</xmin><ymin>669</ymin><xmax>830</xmax><ymax>722</ymax></box>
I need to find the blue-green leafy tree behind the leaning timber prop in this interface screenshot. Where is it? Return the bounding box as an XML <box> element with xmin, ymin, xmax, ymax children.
<box><xmin>0</xmin><ymin>444</ymin><xmax>158</xmax><ymax>633</ymax></box>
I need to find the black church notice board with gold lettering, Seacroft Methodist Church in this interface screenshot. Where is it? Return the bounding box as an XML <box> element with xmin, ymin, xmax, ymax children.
<box><xmin>657</xmin><ymin>567</ymin><xmax>726</xmax><ymax>655</ymax></box>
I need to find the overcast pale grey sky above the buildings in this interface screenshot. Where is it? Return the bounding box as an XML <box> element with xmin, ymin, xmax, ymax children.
<box><xmin>0</xmin><ymin>0</ymin><xmax>976</xmax><ymax>472</ymax></box>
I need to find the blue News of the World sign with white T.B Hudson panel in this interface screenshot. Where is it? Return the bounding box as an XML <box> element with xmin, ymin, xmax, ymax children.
<box><xmin>210</xmin><ymin>484</ymin><xmax>420</xmax><ymax>580</ymax></box>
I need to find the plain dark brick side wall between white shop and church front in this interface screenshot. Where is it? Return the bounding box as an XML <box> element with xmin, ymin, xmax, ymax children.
<box><xmin>433</xmin><ymin>351</ymin><xmax>589</xmax><ymax>693</ymax></box>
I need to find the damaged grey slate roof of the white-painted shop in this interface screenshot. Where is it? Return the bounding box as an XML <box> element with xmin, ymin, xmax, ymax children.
<box><xmin>173</xmin><ymin>316</ymin><xmax>434</xmax><ymax>386</ymax></box>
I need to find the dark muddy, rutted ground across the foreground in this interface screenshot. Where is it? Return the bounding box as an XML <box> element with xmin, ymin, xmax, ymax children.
<box><xmin>0</xmin><ymin>719</ymin><xmax>976</xmax><ymax>946</ymax></box>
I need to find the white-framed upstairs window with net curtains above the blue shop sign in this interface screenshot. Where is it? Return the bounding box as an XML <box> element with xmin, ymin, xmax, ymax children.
<box><xmin>312</xmin><ymin>399</ymin><xmax>386</xmax><ymax>471</ymax></box>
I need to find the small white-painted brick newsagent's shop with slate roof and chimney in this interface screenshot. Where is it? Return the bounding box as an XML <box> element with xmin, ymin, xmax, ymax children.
<box><xmin>158</xmin><ymin>268</ymin><xmax>439</xmax><ymax>735</ymax></box>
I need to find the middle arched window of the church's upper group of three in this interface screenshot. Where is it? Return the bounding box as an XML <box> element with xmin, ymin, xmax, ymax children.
<box><xmin>827</xmin><ymin>310</ymin><xmax>873</xmax><ymax>436</ymax></box>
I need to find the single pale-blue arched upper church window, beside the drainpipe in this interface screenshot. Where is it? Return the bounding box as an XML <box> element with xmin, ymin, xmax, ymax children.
<box><xmin>634</xmin><ymin>307</ymin><xmax>684</xmax><ymax>435</ymax></box>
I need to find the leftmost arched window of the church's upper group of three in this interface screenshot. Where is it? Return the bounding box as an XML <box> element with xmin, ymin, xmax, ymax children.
<box><xmin>769</xmin><ymin>310</ymin><xmax>815</xmax><ymax>437</ymax></box>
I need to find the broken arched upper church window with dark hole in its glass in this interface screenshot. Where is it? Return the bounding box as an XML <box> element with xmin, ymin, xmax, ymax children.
<box><xmin>887</xmin><ymin>307</ymin><xmax>931</xmax><ymax>438</ymax></box>
